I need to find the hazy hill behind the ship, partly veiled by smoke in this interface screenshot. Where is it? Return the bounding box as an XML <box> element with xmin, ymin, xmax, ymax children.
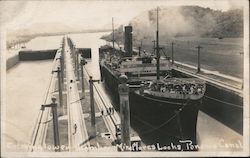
<box><xmin>103</xmin><ymin>6</ymin><xmax>243</xmax><ymax>41</ymax></box>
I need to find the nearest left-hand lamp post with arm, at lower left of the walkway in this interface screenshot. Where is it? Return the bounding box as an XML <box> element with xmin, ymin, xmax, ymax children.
<box><xmin>41</xmin><ymin>97</ymin><xmax>60</xmax><ymax>152</ymax></box>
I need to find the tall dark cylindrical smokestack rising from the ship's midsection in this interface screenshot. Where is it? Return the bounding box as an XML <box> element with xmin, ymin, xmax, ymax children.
<box><xmin>124</xmin><ymin>26</ymin><xmax>133</xmax><ymax>57</ymax></box>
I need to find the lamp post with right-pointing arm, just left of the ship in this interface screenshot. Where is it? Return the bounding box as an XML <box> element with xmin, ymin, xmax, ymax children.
<box><xmin>89</xmin><ymin>76</ymin><xmax>100</xmax><ymax>136</ymax></box>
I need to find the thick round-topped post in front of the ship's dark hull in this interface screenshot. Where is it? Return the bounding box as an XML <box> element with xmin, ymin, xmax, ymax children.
<box><xmin>118</xmin><ymin>75</ymin><xmax>130</xmax><ymax>147</ymax></box>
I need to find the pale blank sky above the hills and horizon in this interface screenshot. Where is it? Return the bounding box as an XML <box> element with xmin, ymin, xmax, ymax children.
<box><xmin>0</xmin><ymin>0</ymin><xmax>247</xmax><ymax>30</ymax></box>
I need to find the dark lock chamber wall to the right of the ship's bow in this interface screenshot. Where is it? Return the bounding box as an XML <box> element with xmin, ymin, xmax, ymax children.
<box><xmin>172</xmin><ymin>70</ymin><xmax>243</xmax><ymax>135</ymax></box>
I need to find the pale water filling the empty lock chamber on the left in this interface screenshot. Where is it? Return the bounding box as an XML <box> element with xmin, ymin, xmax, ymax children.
<box><xmin>5</xmin><ymin>60</ymin><xmax>53</xmax><ymax>151</ymax></box>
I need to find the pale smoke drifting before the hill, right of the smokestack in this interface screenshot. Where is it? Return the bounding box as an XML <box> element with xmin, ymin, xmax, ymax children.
<box><xmin>130</xmin><ymin>7</ymin><xmax>216</xmax><ymax>39</ymax></box>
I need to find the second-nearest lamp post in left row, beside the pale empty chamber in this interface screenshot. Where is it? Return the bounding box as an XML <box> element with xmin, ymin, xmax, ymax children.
<box><xmin>52</xmin><ymin>67</ymin><xmax>64</xmax><ymax>116</ymax></box>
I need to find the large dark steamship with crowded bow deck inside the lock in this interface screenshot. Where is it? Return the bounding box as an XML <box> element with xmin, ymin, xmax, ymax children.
<box><xmin>99</xmin><ymin>8</ymin><xmax>206</xmax><ymax>150</ymax></box>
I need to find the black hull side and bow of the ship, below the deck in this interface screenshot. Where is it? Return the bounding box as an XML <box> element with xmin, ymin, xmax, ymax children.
<box><xmin>100</xmin><ymin>63</ymin><xmax>201</xmax><ymax>150</ymax></box>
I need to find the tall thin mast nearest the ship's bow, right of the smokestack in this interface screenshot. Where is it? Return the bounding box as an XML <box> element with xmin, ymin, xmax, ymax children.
<box><xmin>156</xmin><ymin>7</ymin><xmax>160</xmax><ymax>80</ymax></box>
